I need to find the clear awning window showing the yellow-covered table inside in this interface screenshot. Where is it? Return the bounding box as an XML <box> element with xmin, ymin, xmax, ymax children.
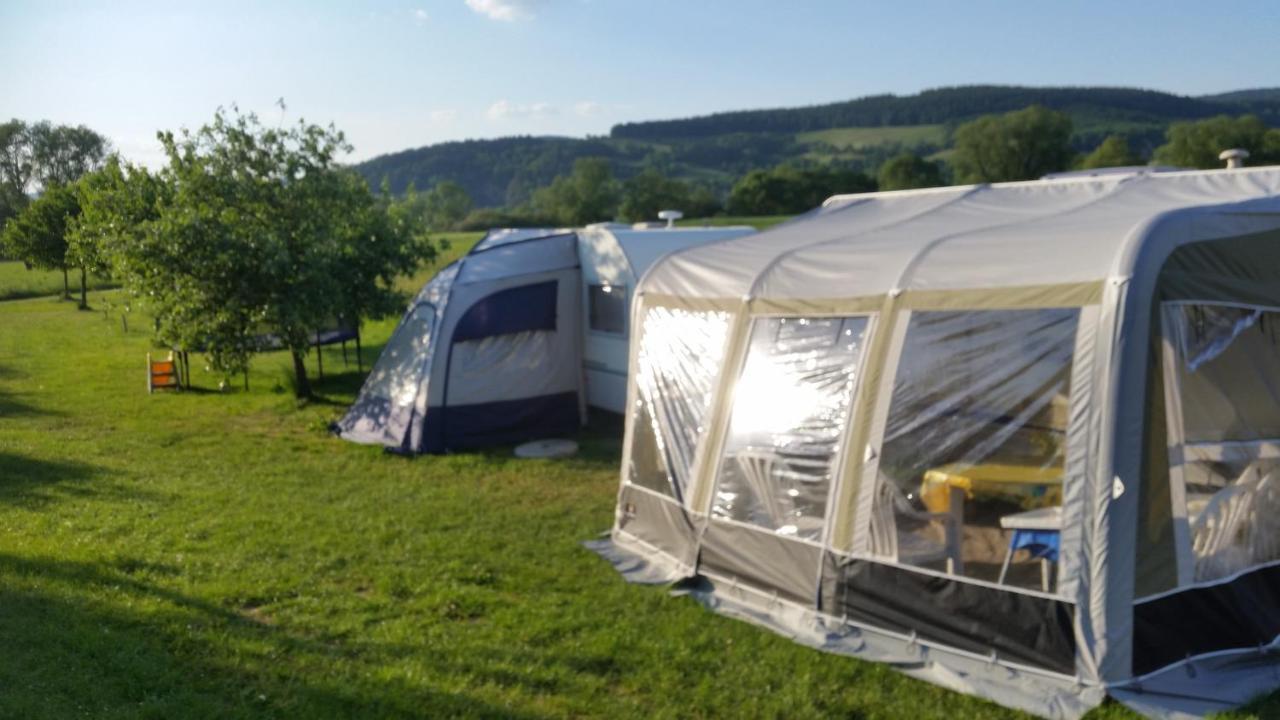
<box><xmin>869</xmin><ymin>309</ymin><xmax>1079</xmax><ymax>592</ymax></box>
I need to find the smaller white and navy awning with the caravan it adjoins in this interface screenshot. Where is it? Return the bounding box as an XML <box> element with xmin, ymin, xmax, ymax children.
<box><xmin>337</xmin><ymin>223</ymin><xmax>754</xmax><ymax>452</ymax></box>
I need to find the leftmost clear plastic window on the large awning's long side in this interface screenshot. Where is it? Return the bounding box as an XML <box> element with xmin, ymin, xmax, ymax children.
<box><xmin>627</xmin><ymin>307</ymin><xmax>730</xmax><ymax>501</ymax></box>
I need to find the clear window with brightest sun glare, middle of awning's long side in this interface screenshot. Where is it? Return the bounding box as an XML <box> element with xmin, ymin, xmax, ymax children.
<box><xmin>712</xmin><ymin>318</ymin><xmax>868</xmax><ymax>541</ymax></box>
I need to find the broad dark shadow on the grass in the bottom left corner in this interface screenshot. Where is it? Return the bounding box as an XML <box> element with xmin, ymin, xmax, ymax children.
<box><xmin>0</xmin><ymin>545</ymin><xmax>545</xmax><ymax>717</ymax></box>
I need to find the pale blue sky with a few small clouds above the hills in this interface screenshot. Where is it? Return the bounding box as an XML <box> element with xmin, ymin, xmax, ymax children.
<box><xmin>0</xmin><ymin>0</ymin><xmax>1280</xmax><ymax>165</ymax></box>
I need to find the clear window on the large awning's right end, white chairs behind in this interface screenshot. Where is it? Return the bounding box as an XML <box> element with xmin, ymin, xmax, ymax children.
<box><xmin>1164</xmin><ymin>304</ymin><xmax>1280</xmax><ymax>582</ymax></box>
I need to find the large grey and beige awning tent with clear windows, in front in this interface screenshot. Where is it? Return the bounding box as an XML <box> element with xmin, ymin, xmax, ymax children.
<box><xmin>596</xmin><ymin>168</ymin><xmax>1280</xmax><ymax>717</ymax></box>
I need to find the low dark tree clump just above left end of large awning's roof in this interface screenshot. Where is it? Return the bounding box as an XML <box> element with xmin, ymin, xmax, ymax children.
<box><xmin>728</xmin><ymin>165</ymin><xmax>876</xmax><ymax>215</ymax></box>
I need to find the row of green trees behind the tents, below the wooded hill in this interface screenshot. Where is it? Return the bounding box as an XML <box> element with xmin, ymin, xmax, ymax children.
<box><xmin>431</xmin><ymin>105</ymin><xmax>1280</xmax><ymax>221</ymax></box>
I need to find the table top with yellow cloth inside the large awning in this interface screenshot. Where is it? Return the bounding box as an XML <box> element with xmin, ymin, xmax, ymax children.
<box><xmin>920</xmin><ymin>462</ymin><xmax>1062</xmax><ymax>519</ymax></box>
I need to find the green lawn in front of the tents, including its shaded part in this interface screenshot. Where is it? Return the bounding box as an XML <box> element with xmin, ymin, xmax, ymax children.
<box><xmin>0</xmin><ymin>243</ymin><xmax>1280</xmax><ymax>720</ymax></box>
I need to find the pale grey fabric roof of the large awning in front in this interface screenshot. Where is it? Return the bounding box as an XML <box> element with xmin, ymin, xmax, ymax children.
<box><xmin>641</xmin><ymin>167</ymin><xmax>1280</xmax><ymax>300</ymax></box>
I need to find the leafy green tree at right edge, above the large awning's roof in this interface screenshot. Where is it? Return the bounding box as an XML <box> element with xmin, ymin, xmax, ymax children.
<box><xmin>1156</xmin><ymin>115</ymin><xmax>1280</xmax><ymax>169</ymax></box>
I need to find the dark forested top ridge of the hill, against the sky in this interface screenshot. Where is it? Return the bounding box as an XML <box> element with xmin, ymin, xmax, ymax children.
<box><xmin>609</xmin><ymin>85</ymin><xmax>1280</xmax><ymax>140</ymax></box>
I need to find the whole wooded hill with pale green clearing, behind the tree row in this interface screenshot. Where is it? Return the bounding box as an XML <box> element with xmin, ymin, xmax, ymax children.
<box><xmin>356</xmin><ymin>85</ymin><xmax>1280</xmax><ymax>206</ymax></box>
